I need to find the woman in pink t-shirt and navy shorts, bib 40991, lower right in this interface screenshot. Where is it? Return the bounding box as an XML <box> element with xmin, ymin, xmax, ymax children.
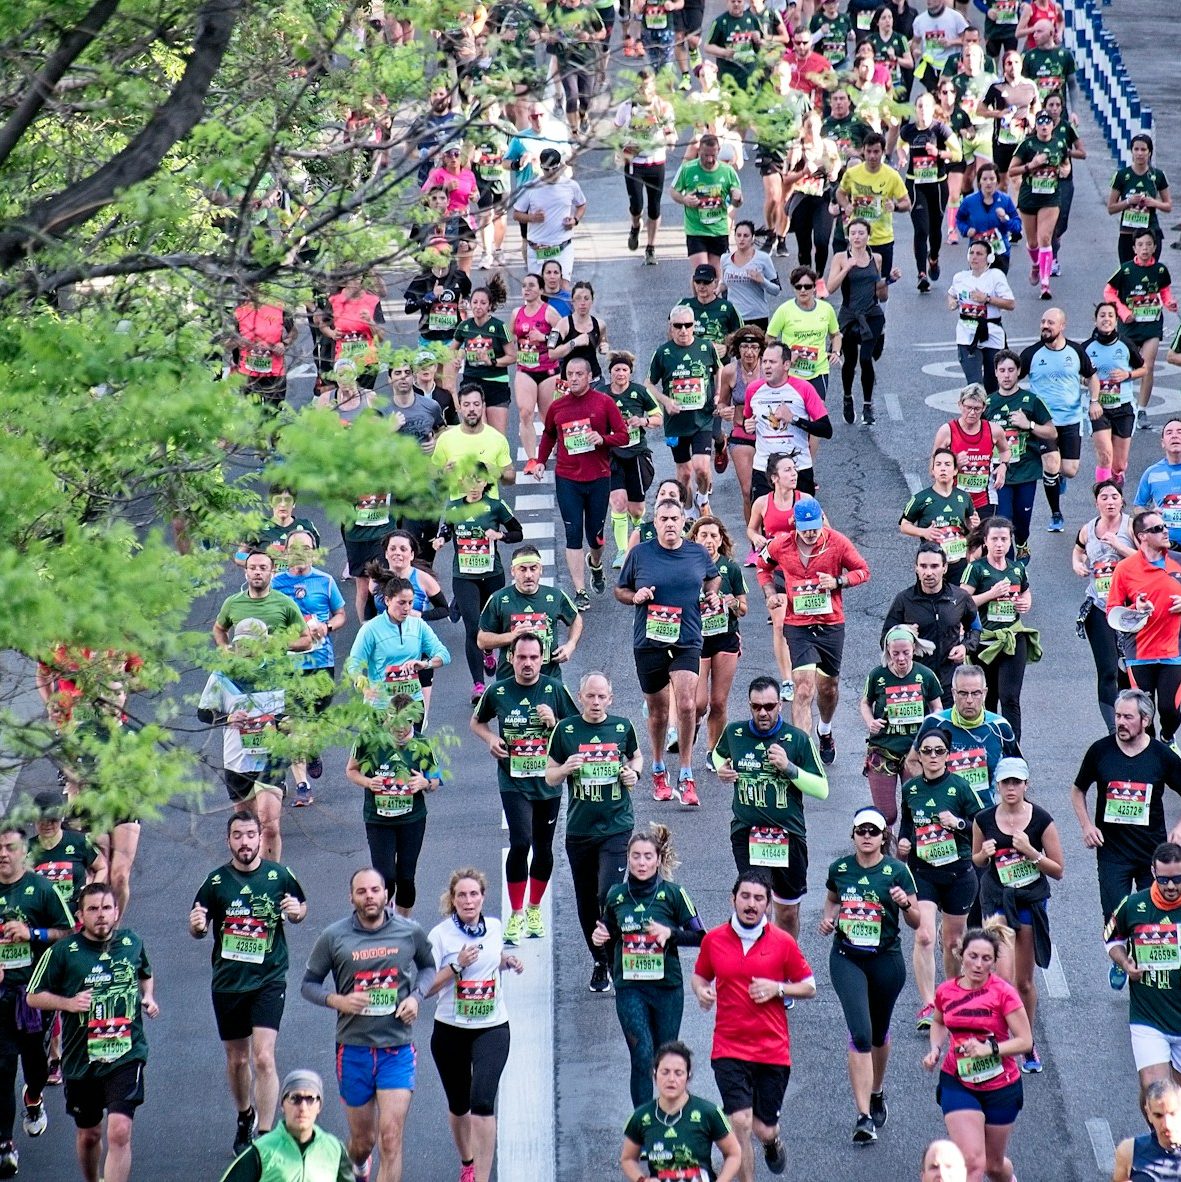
<box><xmin>922</xmin><ymin>928</ymin><xmax>1033</xmax><ymax>1182</ymax></box>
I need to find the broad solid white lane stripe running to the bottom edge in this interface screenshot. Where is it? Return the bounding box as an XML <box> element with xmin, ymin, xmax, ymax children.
<box><xmin>497</xmin><ymin>850</ymin><xmax>557</xmax><ymax>1180</ymax></box>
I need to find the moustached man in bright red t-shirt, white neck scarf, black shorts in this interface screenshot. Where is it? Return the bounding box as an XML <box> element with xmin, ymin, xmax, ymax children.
<box><xmin>690</xmin><ymin>868</ymin><xmax>816</xmax><ymax>1182</ymax></box>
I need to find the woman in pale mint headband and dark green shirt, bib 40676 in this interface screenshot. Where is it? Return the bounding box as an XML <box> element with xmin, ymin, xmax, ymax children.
<box><xmin>858</xmin><ymin>625</ymin><xmax>942</xmax><ymax>827</ymax></box>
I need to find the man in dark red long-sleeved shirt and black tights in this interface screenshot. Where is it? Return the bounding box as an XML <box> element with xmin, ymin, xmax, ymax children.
<box><xmin>532</xmin><ymin>357</ymin><xmax>628</xmax><ymax>611</ymax></box>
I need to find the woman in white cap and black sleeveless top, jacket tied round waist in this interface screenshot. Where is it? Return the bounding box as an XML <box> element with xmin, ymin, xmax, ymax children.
<box><xmin>972</xmin><ymin>758</ymin><xmax>1065</xmax><ymax>1073</ymax></box>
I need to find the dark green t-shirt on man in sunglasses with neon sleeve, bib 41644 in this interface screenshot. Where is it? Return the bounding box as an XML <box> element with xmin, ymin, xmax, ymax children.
<box><xmin>713</xmin><ymin>720</ymin><xmax>826</xmax><ymax>846</ymax></box>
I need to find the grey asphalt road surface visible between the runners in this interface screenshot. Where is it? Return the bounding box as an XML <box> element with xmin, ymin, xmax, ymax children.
<box><xmin>11</xmin><ymin>27</ymin><xmax>1181</xmax><ymax>1182</ymax></box>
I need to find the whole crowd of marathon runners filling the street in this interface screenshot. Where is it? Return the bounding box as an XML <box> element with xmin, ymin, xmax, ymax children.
<box><xmin>0</xmin><ymin>0</ymin><xmax>1181</xmax><ymax>1182</ymax></box>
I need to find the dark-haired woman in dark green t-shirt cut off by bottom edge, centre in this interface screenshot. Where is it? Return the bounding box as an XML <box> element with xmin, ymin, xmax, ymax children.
<box><xmin>619</xmin><ymin>1040</ymin><xmax>742</xmax><ymax>1182</ymax></box>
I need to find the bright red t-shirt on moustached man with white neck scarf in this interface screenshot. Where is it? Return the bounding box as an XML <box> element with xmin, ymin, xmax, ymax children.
<box><xmin>693</xmin><ymin>923</ymin><xmax>812</xmax><ymax>1067</ymax></box>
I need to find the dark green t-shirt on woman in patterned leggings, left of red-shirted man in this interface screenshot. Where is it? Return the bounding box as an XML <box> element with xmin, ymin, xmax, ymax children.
<box><xmin>603</xmin><ymin>875</ymin><xmax>697</xmax><ymax>991</ymax></box>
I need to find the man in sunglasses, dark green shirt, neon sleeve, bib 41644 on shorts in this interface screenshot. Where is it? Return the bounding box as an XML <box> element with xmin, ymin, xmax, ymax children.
<box><xmin>712</xmin><ymin>676</ymin><xmax>829</xmax><ymax>940</ymax></box>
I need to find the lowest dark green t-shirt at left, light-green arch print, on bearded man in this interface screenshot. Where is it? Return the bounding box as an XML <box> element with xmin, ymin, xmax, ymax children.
<box><xmin>28</xmin><ymin>928</ymin><xmax>151</xmax><ymax>1082</ymax></box>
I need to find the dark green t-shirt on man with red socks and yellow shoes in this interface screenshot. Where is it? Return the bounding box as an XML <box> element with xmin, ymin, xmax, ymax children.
<box><xmin>475</xmin><ymin>669</ymin><xmax>578</xmax><ymax>800</ymax></box>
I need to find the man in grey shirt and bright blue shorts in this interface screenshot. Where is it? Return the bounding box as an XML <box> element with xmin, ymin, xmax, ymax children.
<box><xmin>300</xmin><ymin>866</ymin><xmax>435</xmax><ymax>1182</ymax></box>
